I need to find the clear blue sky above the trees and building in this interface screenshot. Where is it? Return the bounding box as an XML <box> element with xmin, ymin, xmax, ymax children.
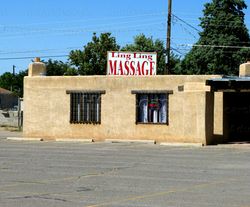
<box><xmin>0</xmin><ymin>0</ymin><xmax>250</xmax><ymax>74</ymax></box>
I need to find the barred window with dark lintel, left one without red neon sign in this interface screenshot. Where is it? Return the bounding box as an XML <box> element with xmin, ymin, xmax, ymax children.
<box><xmin>67</xmin><ymin>91</ymin><xmax>105</xmax><ymax>124</ymax></box>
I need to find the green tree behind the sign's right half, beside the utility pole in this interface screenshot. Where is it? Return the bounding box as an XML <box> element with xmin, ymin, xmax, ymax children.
<box><xmin>122</xmin><ymin>34</ymin><xmax>180</xmax><ymax>75</ymax></box>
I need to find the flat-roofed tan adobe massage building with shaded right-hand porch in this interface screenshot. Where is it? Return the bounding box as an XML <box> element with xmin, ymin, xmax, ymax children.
<box><xmin>23</xmin><ymin>57</ymin><xmax>250</xmax><ymax>145</ymax></box>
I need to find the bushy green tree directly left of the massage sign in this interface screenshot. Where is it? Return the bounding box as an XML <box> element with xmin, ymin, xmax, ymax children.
<box><xmin>69</xmin><ymin>33</ymin><xmax>120</xmax><ymax>75</ymax></box>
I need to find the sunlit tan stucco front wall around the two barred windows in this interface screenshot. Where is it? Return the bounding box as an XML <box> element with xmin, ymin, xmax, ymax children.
<box><xmin>23</xmin><ymin>76</ymin><xmax>222</xmax><ymax>144</ymax></box>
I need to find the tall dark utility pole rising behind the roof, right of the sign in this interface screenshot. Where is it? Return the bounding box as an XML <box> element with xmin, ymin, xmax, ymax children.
<box><xmin>164</xmin><ymin>0</ymin><xmax>172</xmax><ymax>75</ymax></box>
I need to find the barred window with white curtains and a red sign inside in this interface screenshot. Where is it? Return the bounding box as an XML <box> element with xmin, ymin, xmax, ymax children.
<box><xmin>132</xmin><ymin>91</ymin><xmax>172</xmax><ymax>124</ymax></box>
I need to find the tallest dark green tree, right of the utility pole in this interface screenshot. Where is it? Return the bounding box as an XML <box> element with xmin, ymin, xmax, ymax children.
<box><xmin>179</xmin><ymin>0</ymin><xmax>250</xmax><ymax>75</ymax></box>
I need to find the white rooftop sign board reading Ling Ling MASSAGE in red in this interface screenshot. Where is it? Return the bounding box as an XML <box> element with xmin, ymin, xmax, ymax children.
<box><xmin>107</xmin><ymin>51</ymin><xmax>157</xmax><ymax>76</ymax></box>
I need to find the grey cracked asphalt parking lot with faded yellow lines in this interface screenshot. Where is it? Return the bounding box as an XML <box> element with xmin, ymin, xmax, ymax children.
<box><xmin>0</xmin><ymin>134</ymin><xmax>250</xmax><ymax>207</ymax></box>
